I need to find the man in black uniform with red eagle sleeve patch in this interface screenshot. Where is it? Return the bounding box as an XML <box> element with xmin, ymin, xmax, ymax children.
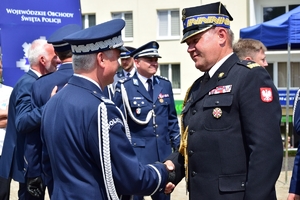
<box><xmin>166</xmin><ymin>2</ymin><xmax>283</xmax><ymax>200</ymax></box>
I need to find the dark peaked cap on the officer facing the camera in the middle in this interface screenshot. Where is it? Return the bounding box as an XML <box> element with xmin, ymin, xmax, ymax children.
<box><xmin>130</xmin><ymin>41</ymin><xmax>161</xmax><ymax>59</ymax></box>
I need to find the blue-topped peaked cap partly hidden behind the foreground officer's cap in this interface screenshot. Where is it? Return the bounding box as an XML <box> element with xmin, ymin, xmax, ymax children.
<box><xmin>47</xmin><ymin>24</ymin><xmax>81</xmax><ymax>52</ymax></box>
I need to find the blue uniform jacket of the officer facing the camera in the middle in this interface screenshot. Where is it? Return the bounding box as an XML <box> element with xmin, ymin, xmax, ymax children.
<box><xmin>114</xmin><ymin>73</ymin><xmax>180</xmax><ymax>164</ymax></box>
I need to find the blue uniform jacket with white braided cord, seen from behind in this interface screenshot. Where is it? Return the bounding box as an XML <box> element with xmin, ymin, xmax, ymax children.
<box><xmin>41</xmin><ymin>75</ymin><xmax>168</xmax><ymax>200</ymax></box>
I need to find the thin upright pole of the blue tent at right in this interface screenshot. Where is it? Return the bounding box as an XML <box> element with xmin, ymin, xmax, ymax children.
<box><xmin>284</xmin><ymin>42</ymin><xmax>291</xmax><ymax>184</ymax></box>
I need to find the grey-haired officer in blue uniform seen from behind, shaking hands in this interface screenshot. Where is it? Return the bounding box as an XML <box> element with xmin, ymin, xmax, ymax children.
<box><xmin>41</xmin><ymin>19</ymin><xmax>172</xmax><ymax>200</ymax></box>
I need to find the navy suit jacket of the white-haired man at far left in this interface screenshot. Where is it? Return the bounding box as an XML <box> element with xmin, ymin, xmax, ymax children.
<box><xmin>0</xmin><ymin>70</ymin><xmax>38</xmax><ymax>183</ymax></box>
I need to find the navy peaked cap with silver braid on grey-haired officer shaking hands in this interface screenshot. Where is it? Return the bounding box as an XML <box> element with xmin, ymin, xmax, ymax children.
<box><xmin>64</xmin><ymin>19</ymin><xmax>128</xmax><ymax>55</ymax></box>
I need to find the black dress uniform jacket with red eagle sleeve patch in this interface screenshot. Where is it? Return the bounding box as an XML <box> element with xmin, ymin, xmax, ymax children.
<box><xmin>169</xmin><ymin>54</ymin><xmax>283</xmax><ymax>200</ymax></box>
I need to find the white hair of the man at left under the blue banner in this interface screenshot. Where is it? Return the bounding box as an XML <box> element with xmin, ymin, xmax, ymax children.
<box><xmin>28</xmin><ymin>39</ymin><xmax>49</xmax><ymax>66</ymax></box>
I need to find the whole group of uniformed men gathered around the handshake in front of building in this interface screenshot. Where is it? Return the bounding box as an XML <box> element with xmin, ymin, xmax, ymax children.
<box><xmin>0</xmin><ymin>2</ymin><xmax>290</xmax><ymax>200</ymax></box>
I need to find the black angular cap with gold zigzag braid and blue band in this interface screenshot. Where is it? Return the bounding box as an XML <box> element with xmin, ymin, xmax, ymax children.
<box><xmin>181</xmin><ymin>2</ymin><xmax>233</xmax><ymax>43</ymax></box>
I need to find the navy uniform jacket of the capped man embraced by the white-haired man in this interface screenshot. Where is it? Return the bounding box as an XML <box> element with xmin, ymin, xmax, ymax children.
<box><xmin>25</xmin><ymin>63</ymin><xmax>74</xmax><ymax>182</ymax></box>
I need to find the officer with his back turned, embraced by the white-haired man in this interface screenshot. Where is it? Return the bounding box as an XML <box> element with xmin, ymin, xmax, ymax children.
<box><xmin>25</xmin><ymin>24</ymin><xmax>81</xmax><ymax>197</ymax></box>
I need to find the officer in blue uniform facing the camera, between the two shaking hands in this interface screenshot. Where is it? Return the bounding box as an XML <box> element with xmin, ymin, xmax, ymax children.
<box><xmin>114</xmin><ymin>41</ymin><xmax>180</xmax><ymax>200</ymax></box>
